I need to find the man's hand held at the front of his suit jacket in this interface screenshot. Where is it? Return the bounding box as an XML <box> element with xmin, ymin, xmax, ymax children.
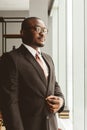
<box><xmin>46</xmin><ymin>95</ymin><xmax>63</xmax><ymax>113</ymax></box>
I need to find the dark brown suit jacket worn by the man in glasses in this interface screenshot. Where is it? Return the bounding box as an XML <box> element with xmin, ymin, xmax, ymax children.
<box><xmin>0</xmin><ymin>45</ymin><xmax>64</xmax><ymax>130</ymax></box>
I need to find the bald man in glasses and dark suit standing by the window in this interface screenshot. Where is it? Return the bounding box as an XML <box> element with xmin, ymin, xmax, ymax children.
<box><xmin>0</xmin><ymin>17</ymin><xmax>64</xmax><ymax>130</ymax></box>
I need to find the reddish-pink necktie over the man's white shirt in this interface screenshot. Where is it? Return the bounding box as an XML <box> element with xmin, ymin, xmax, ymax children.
<box><xmin>36</xmin><ymin>53</ymin><xmax>48</xmax><ymax>78</ymax></box>
